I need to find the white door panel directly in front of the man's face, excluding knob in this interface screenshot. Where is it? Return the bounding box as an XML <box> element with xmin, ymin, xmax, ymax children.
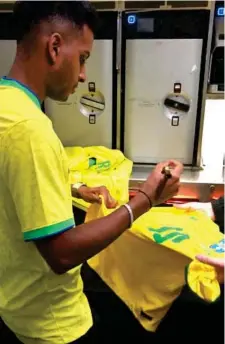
<box><xmin>45</xmin><ymin>40</ymin><xmax>113</xmax><ymax>148</ymax></box>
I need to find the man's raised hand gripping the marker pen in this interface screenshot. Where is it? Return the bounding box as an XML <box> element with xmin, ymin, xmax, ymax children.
<box><xmin>141</xmin><ymin>160</ymin><xmax>183</xmax><ymax>206</ymax></box>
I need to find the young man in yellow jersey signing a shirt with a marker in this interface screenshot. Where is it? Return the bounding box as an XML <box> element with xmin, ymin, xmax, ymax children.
<box><xmin>0</xmin><ymin>1</ymin><xmax>182</xmax><ymax>344</ymax></box>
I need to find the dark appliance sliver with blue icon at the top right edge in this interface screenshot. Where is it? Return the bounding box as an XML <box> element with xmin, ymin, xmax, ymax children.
<box><xmin>208</xmin><ymin>1</ymin><xmax>225</xmax><ymax>93</ymax></box>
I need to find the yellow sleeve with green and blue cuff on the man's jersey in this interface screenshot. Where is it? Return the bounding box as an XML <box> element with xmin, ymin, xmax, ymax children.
<box><xmin>2</xmin><ymin>120</ymin><xmax>75</xmax><ymax>241</ymax></box>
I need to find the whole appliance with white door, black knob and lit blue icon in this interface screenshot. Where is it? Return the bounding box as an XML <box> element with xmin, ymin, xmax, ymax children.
<box><xmin>121</xmin><ymin>9</ymin><xmax>210</xmax><ymax>166</ymax></box>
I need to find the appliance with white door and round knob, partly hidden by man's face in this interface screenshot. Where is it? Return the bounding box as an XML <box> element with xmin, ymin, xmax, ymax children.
<box><xmin>44</xmin><ymin>11</ymin><xmax>117</xmax><ymax>148</ymax></box>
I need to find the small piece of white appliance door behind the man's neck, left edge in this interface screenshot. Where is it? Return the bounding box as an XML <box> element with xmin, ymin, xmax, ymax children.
<box><xmin>0</xmin><ymin>40</ymin><xmax>16</xmax><ymax>78</ymax></box>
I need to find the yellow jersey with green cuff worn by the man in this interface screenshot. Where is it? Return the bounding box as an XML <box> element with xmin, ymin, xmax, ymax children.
<box><xmin>0</xmin><ymin>77</ymin><xmax>92</xmax><ymax>344</ymax></box>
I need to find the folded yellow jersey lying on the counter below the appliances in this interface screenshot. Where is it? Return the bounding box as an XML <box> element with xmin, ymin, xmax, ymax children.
<box><xmin>65</xmin><ymin>146</ymin><xmax>133</xmax><ymax>208</ymax></box>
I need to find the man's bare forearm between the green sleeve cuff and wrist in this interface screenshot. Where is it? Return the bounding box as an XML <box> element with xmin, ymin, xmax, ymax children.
<box><xmin>36</xmin><ymin>194</ymin><xmax>149</xmax><ymax>274</ymax></box>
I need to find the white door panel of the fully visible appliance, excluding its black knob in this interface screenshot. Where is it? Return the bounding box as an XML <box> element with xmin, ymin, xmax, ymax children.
<box><xmin>124</xmin><ymin>39</ymin><xmax>202</xmax><ymax>164</ymax></box>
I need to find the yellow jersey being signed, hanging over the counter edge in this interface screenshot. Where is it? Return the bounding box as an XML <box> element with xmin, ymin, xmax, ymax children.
<box><xmin>86</xmin><ymin>204</ymin><xmax>224</xmax><ymax>331</ymax></box>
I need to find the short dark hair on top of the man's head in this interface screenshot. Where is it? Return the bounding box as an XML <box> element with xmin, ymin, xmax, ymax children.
<box><xmin>13</xmin><ymin>1</ymin><xmax>98</xmax><ymax>43</ymax></box>
